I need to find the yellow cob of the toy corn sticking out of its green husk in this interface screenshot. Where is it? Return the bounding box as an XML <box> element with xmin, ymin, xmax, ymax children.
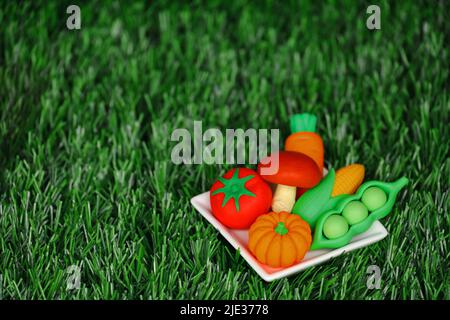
<box><xmin>331</xmin><ymin>163</ymin><xmax>365</xmax><ymax>197</ymax></box>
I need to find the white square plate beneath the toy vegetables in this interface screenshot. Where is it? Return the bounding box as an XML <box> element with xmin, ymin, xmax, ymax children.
<box><xmin>191</xmin><ymin>191</ymin><xmax>388</xmax><ymax>281</ymax></box>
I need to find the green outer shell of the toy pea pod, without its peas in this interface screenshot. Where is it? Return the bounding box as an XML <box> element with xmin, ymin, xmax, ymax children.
<box><xmin>311</xmin><ymin>177</ymin><xmax>408</xmax><ymax>250</ymax></box>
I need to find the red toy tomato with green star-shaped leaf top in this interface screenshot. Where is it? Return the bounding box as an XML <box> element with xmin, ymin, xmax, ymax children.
<box><xmin>210</xmin><ymin>168</ymin><xmax>272</xmax><ymax>229</ymax></box>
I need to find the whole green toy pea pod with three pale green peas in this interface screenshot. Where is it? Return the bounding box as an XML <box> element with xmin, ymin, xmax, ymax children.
<box><xmin>311</xmin><ymin>177</ymin><xmax>408</xmax><ymax>250</ymax></box>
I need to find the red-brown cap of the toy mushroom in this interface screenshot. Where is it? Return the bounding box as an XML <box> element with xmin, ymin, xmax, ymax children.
<box><xmin>258</xmin><ymin>151</ymin><xmax>322</xmax><ymax>188</ymax></box>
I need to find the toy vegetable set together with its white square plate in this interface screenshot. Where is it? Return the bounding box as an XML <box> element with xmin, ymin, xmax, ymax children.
<box><xmin>192</xmin><ymin>113</ymin><xmax>408</xmax><ymax>281</ymax></box>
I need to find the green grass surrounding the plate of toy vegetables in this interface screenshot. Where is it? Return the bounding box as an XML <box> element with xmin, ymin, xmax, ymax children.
<box><xmin>0</xmin><ymin>0</ymin><xmax>450</xmax><ymax>299</ymax></box>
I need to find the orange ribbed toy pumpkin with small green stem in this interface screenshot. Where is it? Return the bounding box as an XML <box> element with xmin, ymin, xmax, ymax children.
<box><xmin>248</xmin><ymin>212</ymin><xmax>312</xmax><ymax>268</ymax></box>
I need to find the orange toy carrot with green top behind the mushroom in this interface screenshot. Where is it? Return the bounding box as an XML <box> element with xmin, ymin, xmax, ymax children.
<box><xmin>284</xmin><ymin>113</ymin><xmax>324</xmax><ymax>172</ymax></box>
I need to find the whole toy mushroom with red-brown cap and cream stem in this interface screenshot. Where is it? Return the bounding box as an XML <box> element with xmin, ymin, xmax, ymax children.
<box><xmin>258</xmin><ymin>151</ymin><xmax>322</xmax><ymax>212</ymax></box>
